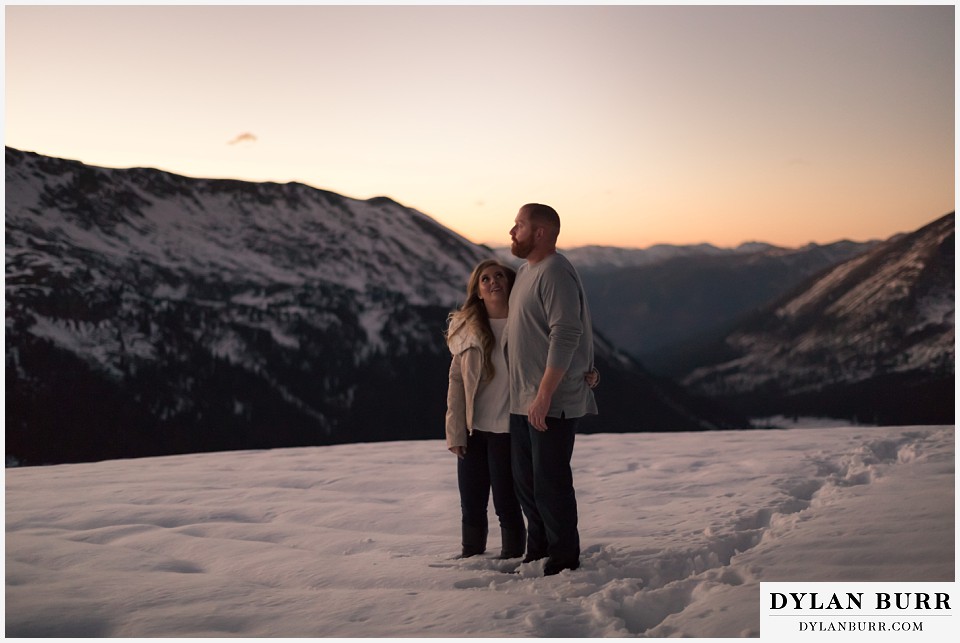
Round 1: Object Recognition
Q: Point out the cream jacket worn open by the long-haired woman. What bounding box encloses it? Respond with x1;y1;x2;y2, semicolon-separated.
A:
446;321;483;448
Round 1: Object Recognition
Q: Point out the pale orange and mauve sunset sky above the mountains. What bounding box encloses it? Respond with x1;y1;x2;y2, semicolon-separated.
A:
5;4;955;247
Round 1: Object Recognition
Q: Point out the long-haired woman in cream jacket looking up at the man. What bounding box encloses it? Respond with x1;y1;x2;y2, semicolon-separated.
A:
446;259;527;558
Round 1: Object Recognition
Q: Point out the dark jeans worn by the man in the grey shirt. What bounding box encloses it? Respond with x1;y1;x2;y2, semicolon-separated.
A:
510;414;580;564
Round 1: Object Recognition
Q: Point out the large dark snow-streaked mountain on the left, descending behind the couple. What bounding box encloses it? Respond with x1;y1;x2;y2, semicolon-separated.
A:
5;148;743;464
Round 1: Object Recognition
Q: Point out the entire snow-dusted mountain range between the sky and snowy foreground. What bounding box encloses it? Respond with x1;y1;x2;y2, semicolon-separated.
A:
5;148;954;464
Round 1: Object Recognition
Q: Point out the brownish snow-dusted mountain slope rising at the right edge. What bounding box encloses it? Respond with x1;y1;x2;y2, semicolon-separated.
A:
683;213;955;423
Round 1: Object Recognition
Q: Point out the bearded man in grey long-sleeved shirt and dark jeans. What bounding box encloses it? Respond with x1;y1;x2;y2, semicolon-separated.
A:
505;203;597;576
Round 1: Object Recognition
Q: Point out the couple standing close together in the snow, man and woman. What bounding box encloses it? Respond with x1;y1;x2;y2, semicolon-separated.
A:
446;203;599;576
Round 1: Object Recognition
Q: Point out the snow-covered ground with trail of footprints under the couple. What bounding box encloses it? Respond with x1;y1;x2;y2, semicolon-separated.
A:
6;427;955;637
